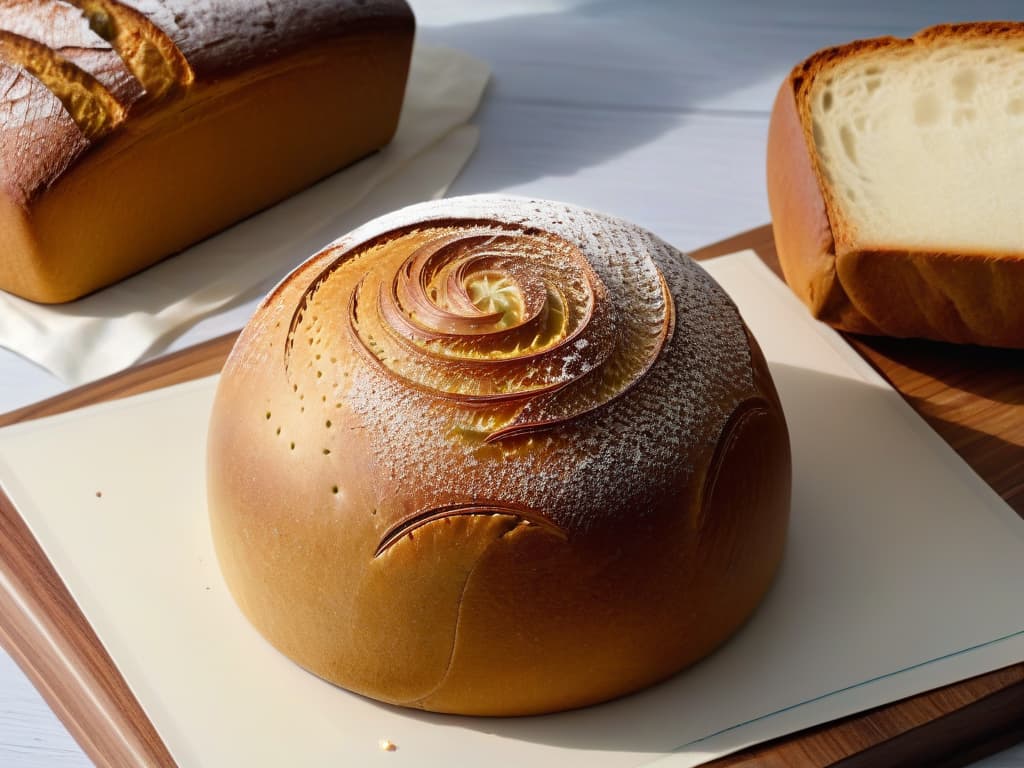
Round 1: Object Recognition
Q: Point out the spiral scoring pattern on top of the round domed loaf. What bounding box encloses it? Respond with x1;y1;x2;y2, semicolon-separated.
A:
287;221;675;441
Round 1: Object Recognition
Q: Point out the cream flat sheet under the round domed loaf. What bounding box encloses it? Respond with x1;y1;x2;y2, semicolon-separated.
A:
0;252;1024;768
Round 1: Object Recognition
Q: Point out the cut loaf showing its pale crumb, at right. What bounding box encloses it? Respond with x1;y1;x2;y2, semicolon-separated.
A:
768;23;1024;347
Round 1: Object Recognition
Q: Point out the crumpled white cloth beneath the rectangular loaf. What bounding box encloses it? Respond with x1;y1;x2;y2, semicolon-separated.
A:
0;46;489;385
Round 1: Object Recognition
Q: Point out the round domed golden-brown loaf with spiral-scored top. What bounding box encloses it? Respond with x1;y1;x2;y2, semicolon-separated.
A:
208;197;791;715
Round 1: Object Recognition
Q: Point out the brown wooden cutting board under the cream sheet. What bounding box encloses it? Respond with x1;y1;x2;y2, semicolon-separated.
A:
0;226;1024;768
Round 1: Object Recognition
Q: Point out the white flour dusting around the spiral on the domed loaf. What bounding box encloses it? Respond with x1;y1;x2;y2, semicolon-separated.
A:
268;197;755;536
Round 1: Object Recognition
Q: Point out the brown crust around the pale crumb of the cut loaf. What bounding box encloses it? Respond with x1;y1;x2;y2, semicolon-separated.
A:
767;22;1024;347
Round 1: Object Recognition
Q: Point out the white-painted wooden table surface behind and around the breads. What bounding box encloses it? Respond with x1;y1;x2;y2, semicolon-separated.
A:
0;0;1024;768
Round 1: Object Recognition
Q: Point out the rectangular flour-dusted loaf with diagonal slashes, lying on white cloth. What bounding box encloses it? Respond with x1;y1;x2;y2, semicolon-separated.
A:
0;0;414;302
